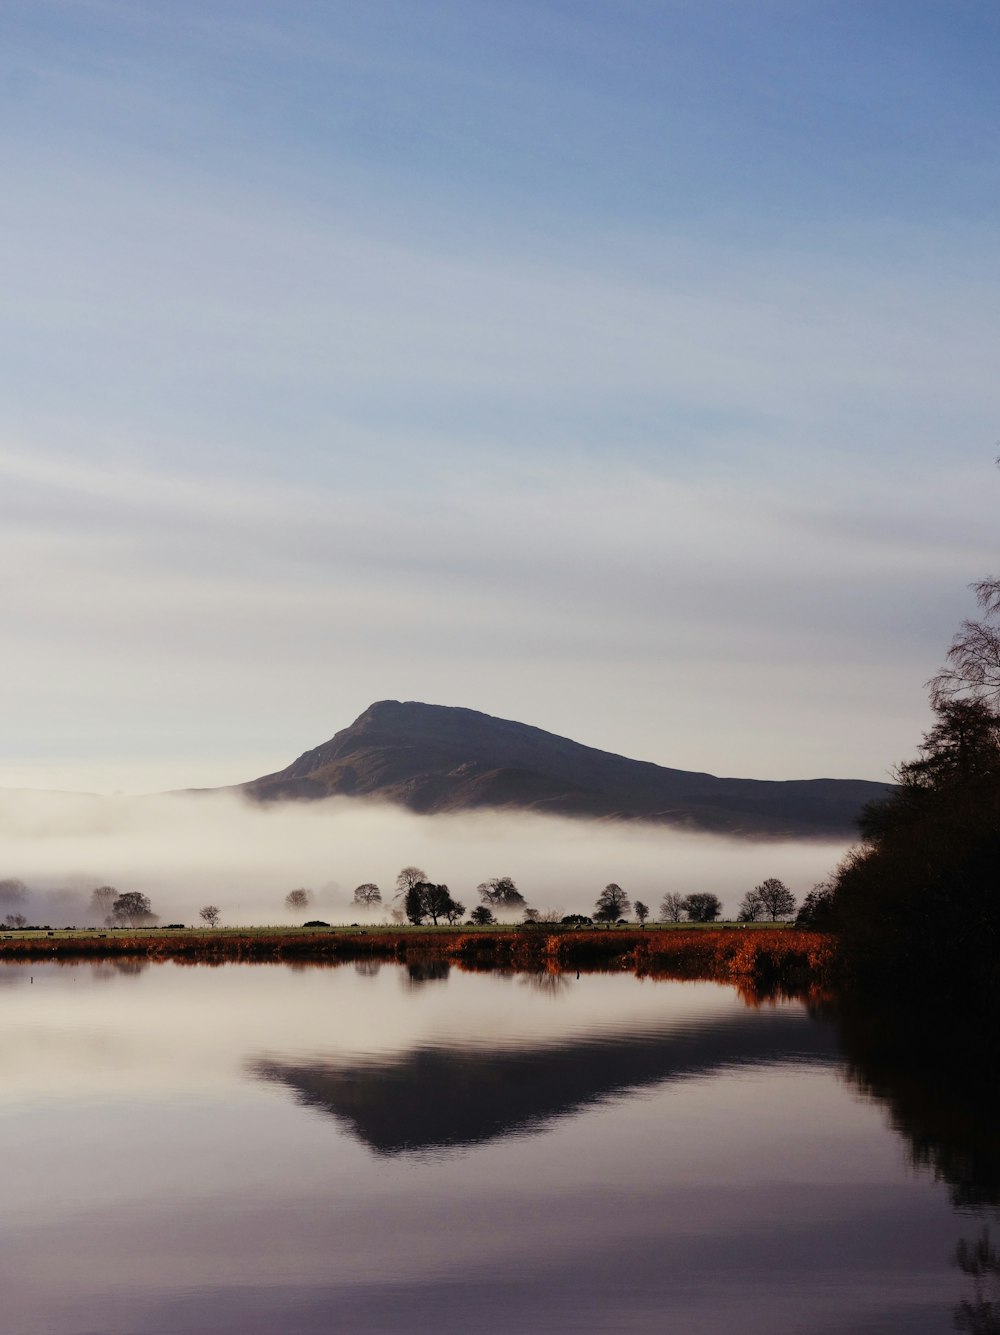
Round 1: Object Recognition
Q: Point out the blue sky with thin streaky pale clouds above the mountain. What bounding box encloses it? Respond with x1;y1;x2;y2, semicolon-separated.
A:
0;0;1000;793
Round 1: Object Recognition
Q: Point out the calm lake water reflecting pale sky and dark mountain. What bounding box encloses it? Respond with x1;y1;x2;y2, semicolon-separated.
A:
0;964;1000;1335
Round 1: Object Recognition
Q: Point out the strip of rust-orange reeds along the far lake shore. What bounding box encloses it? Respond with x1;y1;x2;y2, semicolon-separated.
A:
0;928;834;985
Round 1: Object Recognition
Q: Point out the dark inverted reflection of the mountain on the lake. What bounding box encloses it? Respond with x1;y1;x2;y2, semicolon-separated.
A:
248;1009;837;1155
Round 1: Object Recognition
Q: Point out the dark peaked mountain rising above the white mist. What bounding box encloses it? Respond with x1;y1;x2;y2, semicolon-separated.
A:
239;700;889;838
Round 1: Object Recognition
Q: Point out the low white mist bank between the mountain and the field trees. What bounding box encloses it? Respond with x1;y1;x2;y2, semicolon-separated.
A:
0;792;844;926
